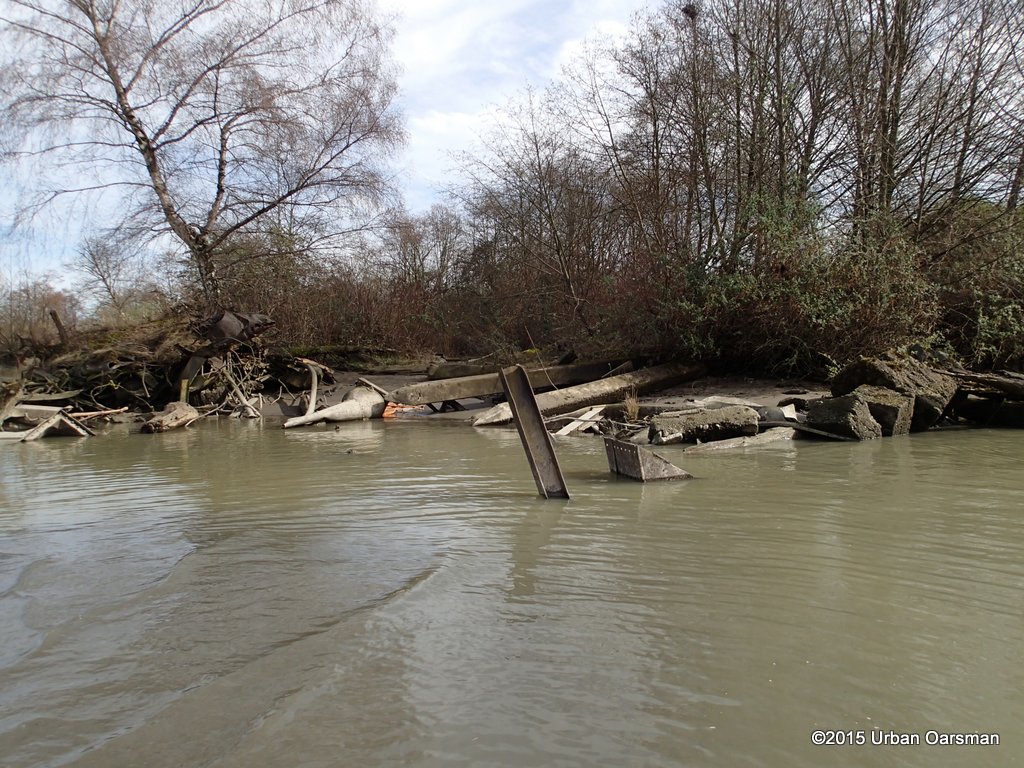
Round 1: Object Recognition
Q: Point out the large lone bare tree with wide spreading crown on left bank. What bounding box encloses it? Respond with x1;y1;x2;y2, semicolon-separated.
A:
0;0;401;303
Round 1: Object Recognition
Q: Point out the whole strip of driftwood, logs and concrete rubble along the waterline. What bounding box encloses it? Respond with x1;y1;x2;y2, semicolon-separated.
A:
0;311;1024;450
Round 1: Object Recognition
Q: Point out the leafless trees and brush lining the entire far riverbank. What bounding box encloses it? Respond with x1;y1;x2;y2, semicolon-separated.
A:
0;0;1024;428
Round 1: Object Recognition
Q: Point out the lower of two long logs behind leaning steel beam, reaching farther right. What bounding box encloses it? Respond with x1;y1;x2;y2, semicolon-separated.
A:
473;362;706;427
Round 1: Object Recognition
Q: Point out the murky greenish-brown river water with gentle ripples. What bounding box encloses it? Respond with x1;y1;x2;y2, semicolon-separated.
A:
0;421;1024;768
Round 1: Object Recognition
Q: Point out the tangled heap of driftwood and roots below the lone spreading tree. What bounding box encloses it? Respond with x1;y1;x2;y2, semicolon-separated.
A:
0;310;334;432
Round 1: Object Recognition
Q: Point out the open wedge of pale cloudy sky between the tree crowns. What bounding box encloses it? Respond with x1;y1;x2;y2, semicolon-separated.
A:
378;0;656;212
